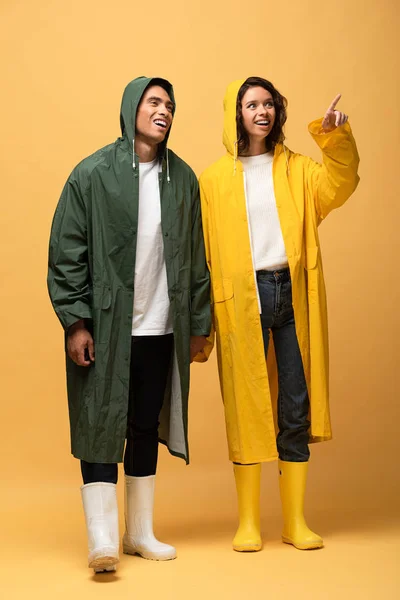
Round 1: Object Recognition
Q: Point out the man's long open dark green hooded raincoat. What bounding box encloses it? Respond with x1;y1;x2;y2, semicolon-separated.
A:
48;77;211;463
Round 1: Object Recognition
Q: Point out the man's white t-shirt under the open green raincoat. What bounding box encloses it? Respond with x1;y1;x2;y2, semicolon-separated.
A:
132;159;173;336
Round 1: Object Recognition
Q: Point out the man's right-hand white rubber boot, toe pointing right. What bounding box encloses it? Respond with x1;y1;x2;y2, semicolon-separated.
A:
122;475;176;560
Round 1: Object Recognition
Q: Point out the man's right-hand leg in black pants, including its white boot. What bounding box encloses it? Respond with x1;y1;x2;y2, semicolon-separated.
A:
123;334;176;560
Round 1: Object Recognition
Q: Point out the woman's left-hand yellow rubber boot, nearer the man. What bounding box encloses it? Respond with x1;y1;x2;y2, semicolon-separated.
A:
233;464;262;552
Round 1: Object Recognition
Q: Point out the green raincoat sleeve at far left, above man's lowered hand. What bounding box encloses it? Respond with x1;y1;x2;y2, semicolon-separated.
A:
47;173;92;330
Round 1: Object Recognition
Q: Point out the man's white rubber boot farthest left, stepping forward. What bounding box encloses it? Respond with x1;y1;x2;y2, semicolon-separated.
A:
81;482;119;573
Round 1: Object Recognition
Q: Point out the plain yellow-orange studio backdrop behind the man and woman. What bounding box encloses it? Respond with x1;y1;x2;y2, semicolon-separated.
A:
0;0;400;599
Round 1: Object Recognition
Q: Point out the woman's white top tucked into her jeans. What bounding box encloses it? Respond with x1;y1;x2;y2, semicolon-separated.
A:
240;152;288;271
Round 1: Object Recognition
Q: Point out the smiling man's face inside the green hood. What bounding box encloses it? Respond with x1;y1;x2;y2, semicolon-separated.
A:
136;85;174;144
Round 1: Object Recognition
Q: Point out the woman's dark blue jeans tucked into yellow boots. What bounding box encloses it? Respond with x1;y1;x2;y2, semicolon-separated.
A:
257;269;310;462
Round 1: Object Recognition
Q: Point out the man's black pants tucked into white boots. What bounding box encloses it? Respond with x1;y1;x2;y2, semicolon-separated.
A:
81;333;174;483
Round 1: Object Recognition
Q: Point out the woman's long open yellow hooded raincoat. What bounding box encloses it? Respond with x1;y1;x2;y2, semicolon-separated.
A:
200;81;359;464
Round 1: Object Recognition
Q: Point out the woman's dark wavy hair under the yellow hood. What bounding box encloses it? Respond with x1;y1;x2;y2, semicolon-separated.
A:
236;77;287;154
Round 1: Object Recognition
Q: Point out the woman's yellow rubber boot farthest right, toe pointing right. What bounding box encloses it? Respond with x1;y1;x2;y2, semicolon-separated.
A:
278;460;324;550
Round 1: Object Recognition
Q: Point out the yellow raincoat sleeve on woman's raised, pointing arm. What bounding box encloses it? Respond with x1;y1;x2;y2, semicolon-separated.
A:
307;119;360;220
